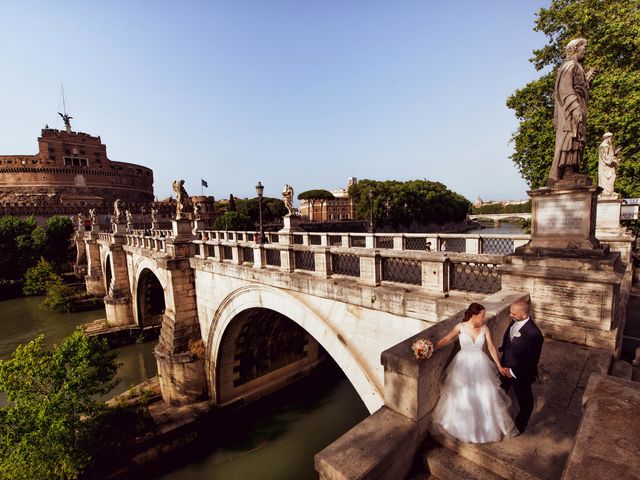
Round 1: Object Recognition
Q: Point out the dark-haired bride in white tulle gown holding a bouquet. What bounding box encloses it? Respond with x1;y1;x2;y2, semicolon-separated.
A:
433;303;518;443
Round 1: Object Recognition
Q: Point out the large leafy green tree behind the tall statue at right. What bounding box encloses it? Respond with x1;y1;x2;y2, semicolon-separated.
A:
507;0;640;197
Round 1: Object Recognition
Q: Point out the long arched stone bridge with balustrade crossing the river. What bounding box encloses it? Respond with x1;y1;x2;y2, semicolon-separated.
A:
84;222;528;412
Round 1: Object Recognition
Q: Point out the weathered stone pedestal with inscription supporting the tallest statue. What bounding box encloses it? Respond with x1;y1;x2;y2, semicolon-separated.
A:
499;182;624;351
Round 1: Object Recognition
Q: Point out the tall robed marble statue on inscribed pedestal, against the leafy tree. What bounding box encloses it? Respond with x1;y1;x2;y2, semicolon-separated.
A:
548;38;596;186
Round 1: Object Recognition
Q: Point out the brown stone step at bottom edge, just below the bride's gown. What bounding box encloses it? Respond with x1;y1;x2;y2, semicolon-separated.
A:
424;447;504;480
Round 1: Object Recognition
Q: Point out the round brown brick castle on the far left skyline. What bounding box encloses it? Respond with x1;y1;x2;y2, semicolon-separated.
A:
0;121;154;222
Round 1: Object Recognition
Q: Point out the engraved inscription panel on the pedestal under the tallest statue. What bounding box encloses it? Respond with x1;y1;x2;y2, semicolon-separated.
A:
535;198;584;236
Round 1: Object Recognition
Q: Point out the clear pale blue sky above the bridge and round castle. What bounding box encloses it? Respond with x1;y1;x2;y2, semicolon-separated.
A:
0;0;549;201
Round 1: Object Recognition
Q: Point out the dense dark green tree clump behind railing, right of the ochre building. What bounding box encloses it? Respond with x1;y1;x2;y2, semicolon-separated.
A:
349;179;471;230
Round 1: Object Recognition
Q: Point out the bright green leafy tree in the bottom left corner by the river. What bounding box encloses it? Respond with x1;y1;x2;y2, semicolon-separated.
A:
0;329;118;480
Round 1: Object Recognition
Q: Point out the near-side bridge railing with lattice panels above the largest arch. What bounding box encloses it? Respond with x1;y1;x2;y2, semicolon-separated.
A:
191;230;526;294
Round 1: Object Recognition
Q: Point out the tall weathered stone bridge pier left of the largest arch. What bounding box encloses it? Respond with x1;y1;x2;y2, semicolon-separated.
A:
154;258;207;405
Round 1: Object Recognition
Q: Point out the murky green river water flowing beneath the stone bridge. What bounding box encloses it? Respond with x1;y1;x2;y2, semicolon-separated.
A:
0;297;368;480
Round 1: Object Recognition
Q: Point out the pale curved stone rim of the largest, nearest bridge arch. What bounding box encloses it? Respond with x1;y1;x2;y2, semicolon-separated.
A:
205;284;384;412
